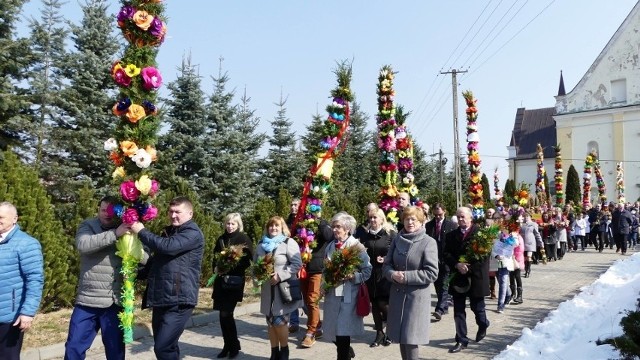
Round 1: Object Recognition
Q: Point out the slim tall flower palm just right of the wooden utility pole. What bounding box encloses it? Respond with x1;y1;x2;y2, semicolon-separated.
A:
462;90;482;221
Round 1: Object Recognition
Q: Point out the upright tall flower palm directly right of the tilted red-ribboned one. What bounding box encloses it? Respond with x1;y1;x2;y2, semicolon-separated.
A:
376;65;399;224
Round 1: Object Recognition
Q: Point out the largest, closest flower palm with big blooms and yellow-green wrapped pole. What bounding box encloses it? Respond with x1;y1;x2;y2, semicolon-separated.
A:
104;0;167;343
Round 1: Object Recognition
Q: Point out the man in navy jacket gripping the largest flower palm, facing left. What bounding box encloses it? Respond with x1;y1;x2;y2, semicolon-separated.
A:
131;197;204;360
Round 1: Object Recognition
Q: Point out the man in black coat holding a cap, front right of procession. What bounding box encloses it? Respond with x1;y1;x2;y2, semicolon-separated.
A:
444;207;489;353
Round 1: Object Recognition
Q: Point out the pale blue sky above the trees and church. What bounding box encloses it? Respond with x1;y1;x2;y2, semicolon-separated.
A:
21;0;636;186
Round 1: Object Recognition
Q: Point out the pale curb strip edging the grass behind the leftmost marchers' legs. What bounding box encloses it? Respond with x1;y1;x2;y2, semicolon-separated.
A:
20;301;260;360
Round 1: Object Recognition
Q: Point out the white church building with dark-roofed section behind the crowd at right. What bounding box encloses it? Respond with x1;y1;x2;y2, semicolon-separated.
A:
508;3;640;203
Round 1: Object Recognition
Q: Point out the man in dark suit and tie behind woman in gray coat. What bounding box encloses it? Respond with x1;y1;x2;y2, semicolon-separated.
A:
425;203;457;321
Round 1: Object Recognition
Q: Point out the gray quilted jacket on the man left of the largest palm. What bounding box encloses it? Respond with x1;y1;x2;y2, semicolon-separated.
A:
76;218;122;308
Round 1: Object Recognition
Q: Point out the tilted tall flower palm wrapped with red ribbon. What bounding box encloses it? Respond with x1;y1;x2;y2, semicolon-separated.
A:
292;61;353;277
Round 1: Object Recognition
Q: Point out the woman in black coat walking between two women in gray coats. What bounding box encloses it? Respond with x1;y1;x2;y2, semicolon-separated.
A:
359;209;396;347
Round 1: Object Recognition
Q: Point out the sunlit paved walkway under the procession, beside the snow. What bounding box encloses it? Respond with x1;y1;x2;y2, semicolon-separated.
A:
32;248;626;360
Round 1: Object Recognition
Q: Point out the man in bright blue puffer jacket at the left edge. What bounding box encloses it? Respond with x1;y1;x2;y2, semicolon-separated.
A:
0;202;44;360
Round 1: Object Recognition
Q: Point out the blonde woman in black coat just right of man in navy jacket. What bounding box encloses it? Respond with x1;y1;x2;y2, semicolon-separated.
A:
211;213;253;359
